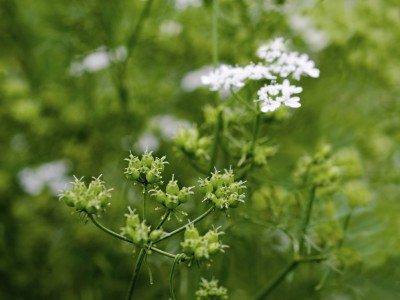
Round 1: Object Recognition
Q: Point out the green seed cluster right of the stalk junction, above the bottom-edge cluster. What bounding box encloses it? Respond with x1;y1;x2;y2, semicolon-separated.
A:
181;225;227;261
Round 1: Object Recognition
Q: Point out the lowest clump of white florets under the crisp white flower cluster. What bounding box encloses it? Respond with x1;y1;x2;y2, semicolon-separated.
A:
257;79;303;112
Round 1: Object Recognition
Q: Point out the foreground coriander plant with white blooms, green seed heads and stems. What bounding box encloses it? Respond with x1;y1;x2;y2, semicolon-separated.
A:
56;1;370;299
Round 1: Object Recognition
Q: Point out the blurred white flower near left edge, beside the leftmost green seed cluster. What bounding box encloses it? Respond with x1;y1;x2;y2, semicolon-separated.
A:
18;160;71;195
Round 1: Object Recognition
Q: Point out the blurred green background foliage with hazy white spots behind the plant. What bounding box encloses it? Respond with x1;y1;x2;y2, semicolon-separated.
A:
0;0;400;299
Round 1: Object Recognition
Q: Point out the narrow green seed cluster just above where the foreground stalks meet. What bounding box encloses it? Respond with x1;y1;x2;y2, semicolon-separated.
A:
121;208;155;247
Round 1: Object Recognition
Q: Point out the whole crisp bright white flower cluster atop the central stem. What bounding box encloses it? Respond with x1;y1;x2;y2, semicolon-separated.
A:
201;38;319;112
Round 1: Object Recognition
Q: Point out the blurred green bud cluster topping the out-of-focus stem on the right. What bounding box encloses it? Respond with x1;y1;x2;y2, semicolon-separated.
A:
294;144;342;188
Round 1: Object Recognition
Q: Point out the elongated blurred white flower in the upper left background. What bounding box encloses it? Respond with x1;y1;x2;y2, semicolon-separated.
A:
69;46;128;76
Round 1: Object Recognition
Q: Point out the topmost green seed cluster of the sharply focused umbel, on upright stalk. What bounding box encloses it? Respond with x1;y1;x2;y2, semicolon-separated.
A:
125;152;167;184
